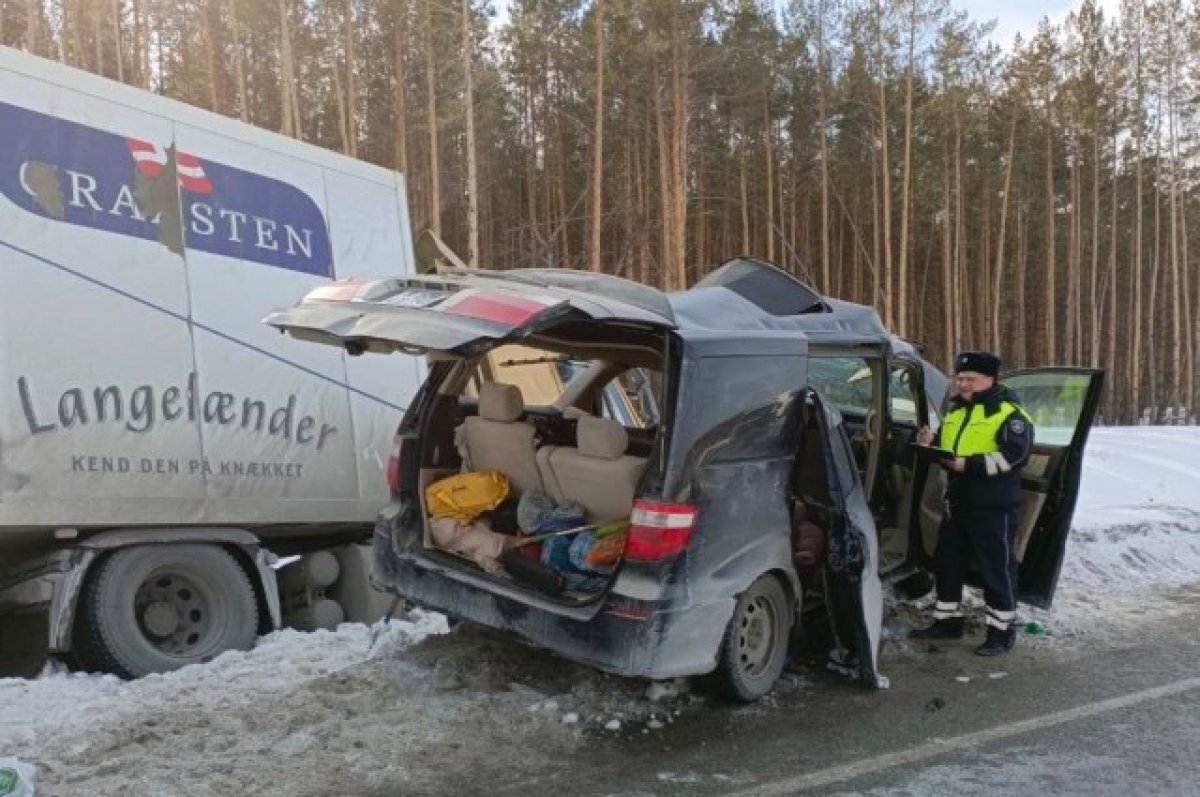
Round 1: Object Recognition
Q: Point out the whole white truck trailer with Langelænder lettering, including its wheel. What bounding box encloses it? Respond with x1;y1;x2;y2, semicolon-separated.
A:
0;47;424;677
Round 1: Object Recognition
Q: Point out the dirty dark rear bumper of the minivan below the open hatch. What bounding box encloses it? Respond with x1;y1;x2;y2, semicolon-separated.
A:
372;525;734;679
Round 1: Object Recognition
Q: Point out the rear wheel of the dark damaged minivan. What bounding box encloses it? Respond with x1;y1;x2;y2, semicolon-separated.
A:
718;575;792;702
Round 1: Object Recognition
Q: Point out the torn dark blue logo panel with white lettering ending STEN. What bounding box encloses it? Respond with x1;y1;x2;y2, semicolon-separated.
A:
0;102;332;277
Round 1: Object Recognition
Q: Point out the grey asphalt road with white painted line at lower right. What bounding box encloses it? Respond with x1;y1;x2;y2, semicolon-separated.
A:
490;593;1200;797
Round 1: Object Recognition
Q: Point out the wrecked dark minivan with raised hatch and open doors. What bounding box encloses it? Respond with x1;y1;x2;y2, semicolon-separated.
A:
266;258;1100;701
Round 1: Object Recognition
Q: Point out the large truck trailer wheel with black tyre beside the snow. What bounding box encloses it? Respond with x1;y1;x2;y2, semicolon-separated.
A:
76;545;258;678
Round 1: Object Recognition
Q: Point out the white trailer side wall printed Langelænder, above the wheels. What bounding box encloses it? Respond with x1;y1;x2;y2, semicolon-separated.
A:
0;48;421;535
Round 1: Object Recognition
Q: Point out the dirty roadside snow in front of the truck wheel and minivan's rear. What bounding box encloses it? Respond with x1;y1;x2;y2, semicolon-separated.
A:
0;612;690;797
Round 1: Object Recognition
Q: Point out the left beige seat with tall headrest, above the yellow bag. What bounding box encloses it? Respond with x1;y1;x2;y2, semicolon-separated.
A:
458;382;544;496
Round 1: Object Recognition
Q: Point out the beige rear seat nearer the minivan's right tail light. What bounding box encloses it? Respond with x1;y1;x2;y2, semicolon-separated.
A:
538;415;646;522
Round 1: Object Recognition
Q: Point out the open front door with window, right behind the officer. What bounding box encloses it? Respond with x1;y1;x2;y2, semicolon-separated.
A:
1001;367;1104;607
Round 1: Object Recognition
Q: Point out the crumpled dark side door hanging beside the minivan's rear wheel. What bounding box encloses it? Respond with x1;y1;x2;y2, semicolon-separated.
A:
808;390;883;685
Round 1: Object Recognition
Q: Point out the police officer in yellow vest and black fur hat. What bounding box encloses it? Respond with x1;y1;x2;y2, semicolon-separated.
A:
912;352;1033;655
